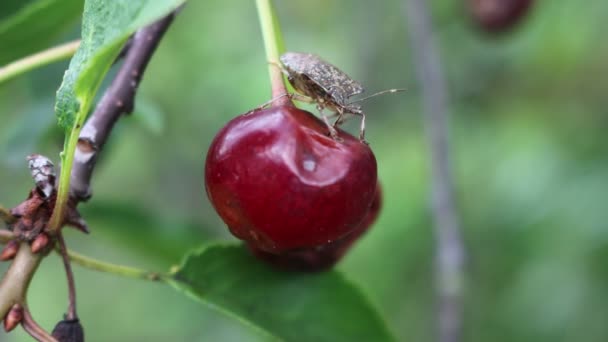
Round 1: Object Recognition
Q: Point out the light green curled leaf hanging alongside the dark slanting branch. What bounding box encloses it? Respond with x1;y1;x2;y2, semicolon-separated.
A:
55;0;185;131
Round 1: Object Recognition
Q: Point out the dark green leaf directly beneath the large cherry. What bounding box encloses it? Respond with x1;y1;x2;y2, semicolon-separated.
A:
171;245;394;342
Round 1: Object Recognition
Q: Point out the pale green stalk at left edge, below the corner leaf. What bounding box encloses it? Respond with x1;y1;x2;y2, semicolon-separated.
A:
0;40;80;84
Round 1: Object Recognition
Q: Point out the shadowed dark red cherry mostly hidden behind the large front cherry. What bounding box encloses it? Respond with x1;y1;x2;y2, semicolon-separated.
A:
249;183;382;272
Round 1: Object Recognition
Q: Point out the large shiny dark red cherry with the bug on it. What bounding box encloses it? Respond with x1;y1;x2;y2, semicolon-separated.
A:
205;106;377;253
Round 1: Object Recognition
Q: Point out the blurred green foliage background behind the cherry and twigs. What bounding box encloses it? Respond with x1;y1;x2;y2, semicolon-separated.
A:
0;0;608;342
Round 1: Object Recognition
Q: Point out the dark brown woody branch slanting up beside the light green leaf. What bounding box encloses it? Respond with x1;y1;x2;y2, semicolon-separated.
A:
70;12;175;201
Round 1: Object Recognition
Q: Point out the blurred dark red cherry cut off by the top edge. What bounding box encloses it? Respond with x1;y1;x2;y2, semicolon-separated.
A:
468;0;533;33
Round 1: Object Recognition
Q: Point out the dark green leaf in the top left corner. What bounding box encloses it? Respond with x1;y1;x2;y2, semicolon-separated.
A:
0;0;83;65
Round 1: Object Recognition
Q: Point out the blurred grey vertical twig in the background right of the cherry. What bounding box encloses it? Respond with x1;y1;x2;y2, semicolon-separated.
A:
407;0;465;342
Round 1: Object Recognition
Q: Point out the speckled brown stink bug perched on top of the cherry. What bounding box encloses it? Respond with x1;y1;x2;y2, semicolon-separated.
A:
279;52;404;141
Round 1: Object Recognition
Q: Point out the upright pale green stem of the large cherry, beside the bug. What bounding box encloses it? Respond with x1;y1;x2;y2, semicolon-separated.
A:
256;0;293;106
